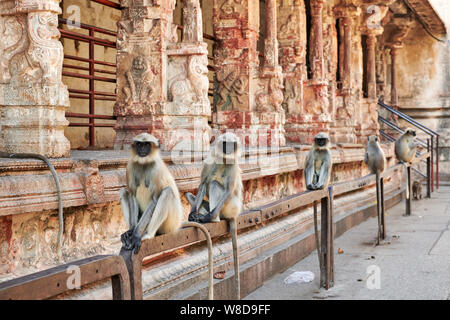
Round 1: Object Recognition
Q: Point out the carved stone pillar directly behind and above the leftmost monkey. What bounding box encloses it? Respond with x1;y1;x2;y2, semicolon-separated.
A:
114;0;211;152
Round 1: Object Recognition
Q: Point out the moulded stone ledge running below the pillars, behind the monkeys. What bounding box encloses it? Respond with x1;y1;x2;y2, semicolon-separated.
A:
0;146;392;216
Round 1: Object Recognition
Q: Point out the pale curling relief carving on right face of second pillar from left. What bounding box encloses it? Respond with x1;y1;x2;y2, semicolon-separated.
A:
187;55;209;101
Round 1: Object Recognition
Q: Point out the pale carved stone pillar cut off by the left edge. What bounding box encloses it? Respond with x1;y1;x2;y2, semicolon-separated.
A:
0;0;70;158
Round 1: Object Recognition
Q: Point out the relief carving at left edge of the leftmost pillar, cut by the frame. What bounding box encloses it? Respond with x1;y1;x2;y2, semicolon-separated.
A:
0;16;28;83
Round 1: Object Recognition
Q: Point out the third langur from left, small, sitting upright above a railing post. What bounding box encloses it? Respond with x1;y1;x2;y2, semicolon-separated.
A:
305;132;333;190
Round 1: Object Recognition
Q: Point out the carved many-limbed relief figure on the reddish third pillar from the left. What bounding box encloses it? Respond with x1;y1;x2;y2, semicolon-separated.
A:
216;69;247;110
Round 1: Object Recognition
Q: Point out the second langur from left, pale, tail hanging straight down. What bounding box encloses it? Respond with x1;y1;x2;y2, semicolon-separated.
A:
186;132;243;300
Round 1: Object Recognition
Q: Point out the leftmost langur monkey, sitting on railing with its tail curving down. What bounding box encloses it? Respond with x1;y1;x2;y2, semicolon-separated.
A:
120;133;214;300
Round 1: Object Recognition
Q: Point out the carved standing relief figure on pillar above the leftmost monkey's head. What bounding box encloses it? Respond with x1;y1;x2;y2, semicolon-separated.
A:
123;56;154;104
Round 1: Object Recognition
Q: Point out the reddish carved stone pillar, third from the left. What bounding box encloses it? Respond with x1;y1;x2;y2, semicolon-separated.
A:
213;0;285;146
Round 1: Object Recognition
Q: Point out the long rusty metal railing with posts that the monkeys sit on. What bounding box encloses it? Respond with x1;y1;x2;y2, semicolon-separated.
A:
0;152;432;300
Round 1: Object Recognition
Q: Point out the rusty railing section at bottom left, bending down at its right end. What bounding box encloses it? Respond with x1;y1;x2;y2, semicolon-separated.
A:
0;255;130;300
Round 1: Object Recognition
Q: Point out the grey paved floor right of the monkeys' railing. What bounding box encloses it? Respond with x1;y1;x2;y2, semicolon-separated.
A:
246;186;450;300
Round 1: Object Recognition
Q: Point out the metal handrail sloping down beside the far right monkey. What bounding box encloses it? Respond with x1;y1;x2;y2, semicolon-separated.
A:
378;101;440;192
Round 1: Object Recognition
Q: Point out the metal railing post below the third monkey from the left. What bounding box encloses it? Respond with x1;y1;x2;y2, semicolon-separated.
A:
320;187;334;290
